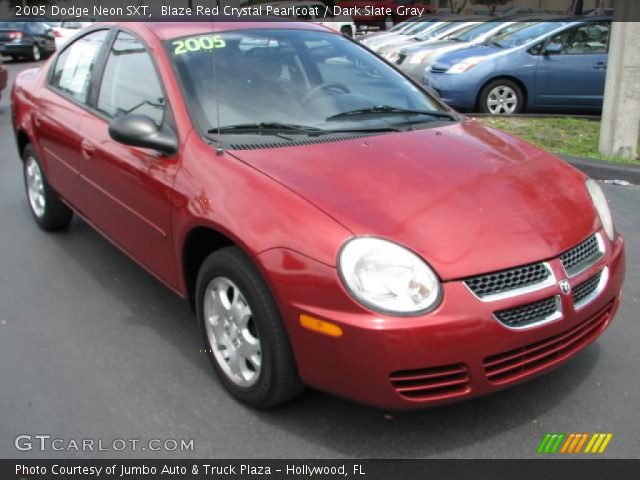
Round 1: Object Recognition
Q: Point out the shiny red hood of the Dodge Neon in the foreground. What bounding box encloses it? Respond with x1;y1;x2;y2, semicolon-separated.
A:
229;120;598;280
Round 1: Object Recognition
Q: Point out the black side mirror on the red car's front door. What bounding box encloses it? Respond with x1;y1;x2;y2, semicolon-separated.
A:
109;113;178;155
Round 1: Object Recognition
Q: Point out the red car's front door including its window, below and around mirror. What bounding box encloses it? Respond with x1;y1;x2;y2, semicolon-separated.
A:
80;31;178;286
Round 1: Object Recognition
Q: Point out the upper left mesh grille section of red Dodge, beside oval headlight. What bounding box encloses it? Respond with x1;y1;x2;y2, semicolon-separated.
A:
464;263;551;299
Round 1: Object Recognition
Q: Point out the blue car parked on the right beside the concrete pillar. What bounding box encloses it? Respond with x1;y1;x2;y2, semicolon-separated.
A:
423;18;611;115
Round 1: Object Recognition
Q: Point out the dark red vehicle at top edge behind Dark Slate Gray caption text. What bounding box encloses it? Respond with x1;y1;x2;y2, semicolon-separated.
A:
336;0;436;30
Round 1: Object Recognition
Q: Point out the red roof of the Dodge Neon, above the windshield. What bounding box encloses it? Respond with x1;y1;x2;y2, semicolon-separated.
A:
107;17;328;40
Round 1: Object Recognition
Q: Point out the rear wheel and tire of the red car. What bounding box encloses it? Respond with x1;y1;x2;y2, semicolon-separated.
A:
22;145;73;231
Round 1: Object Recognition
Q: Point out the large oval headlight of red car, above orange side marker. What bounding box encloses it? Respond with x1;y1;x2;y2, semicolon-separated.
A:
338;237;440;315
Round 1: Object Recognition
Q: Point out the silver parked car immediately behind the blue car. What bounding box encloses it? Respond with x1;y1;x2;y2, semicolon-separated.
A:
395;21;527;82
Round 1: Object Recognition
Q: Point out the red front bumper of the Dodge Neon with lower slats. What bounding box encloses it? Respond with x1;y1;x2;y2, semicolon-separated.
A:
259;232;625;409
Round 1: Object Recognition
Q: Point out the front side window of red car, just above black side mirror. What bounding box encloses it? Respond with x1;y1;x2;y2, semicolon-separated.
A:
96;32;166;126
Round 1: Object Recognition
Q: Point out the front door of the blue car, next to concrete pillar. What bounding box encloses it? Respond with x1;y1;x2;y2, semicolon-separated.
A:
535;22;611;108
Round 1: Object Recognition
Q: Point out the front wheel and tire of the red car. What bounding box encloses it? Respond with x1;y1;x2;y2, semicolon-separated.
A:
196;247;304;409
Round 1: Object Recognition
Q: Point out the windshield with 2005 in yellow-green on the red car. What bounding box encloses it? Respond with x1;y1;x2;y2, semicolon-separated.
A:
167;29;450;133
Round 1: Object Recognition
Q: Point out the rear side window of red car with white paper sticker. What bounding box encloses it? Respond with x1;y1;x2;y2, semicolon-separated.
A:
50;30;109;103
